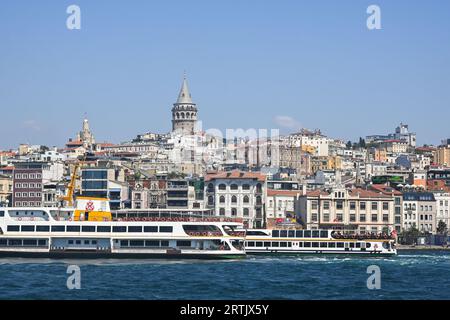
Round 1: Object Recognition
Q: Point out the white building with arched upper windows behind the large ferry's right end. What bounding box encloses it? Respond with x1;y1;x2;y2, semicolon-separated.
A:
205;170;267;228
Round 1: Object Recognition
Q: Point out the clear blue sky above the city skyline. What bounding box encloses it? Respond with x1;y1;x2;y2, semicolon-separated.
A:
0;0;450;149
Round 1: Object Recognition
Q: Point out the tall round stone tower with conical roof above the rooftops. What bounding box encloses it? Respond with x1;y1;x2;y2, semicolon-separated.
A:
172;75;197;135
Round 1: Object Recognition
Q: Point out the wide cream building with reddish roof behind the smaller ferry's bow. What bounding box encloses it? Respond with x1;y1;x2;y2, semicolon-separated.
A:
299;187;395;233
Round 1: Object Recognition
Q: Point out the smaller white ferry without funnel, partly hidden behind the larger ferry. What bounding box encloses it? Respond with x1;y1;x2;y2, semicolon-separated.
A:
245;229;397;255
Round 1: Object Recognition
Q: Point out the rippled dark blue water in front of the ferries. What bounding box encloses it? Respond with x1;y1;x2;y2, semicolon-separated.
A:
0;251;450;300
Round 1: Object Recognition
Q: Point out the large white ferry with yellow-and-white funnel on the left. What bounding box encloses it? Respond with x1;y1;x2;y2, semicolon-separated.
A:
0;197;245;259
